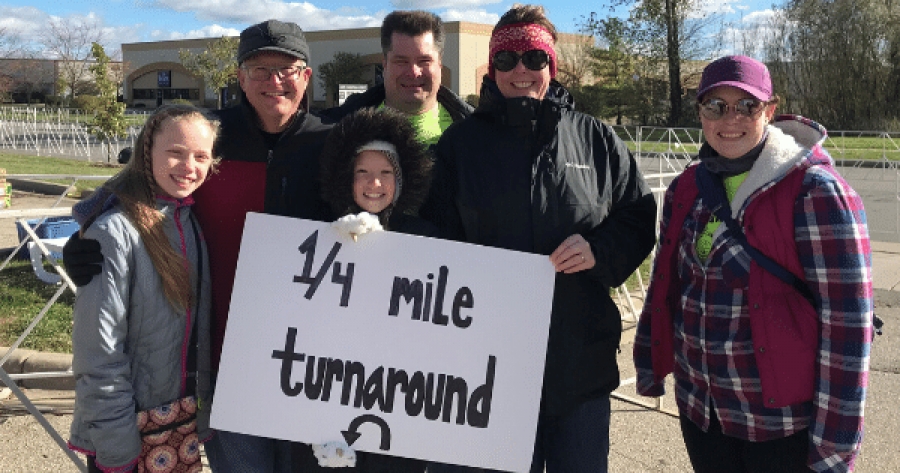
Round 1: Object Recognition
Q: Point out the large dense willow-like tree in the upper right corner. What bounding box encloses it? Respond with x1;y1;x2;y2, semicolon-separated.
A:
764;0;900;130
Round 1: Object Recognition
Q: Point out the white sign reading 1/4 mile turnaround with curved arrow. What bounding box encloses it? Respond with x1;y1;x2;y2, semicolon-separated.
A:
212;213;554;471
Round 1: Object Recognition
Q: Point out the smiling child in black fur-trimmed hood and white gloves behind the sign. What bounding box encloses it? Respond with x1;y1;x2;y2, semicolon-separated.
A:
293;108;438;473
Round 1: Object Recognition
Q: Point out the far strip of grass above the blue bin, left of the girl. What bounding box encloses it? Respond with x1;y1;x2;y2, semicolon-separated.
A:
0;152;122;197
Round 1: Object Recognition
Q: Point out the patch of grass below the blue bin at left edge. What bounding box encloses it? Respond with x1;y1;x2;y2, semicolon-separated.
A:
0;260;75;353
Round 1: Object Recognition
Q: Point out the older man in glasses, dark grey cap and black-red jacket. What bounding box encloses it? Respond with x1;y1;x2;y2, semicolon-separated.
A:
194;20;330;473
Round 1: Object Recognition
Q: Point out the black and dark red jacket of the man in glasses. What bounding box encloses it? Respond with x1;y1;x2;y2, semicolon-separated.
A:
193;100;331;370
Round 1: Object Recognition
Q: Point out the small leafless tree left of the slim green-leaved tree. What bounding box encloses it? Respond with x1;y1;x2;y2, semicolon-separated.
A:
41;18;104;100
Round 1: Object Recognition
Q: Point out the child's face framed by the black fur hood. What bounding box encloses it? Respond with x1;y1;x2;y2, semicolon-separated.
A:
353;150;396;214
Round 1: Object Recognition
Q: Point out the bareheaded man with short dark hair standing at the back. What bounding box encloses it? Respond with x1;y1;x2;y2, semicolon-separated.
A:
320;10;472;146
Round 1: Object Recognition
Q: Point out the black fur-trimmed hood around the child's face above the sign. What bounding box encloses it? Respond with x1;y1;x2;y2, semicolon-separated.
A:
319;108;433;229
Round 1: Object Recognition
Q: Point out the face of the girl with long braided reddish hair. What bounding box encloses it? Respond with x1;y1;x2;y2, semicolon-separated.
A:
151;118;215;199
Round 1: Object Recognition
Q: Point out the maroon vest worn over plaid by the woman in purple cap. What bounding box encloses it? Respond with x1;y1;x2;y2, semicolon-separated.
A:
648;166;820;408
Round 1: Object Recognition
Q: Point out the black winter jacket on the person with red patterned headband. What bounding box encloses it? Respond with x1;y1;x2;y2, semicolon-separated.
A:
423;78;656;417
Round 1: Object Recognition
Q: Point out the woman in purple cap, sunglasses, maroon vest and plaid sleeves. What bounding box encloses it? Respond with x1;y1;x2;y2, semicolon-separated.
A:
634;56;873;473
